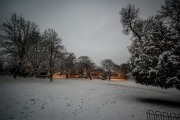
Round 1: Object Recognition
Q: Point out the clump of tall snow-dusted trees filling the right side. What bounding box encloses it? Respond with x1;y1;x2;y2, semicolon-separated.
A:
120;0;180;90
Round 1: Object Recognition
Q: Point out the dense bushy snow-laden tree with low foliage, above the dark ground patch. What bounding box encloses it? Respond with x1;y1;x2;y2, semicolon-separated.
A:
129;21;178;88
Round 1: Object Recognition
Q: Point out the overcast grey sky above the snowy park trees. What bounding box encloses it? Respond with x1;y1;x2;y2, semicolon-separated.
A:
0;0;164;65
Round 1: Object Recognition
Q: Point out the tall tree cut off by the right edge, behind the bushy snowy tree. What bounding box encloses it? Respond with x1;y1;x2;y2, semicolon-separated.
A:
158;0;180;90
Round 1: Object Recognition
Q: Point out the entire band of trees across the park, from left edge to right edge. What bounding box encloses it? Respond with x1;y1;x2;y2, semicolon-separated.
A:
0;0;180;90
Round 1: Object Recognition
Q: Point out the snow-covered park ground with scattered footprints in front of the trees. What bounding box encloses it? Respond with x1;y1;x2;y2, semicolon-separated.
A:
0;76;180;120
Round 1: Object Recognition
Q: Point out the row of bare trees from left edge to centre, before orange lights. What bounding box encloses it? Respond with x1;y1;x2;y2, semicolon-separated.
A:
0;13;127;82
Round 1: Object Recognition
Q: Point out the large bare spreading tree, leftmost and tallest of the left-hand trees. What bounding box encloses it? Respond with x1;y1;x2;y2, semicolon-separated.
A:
0;14;38;78
